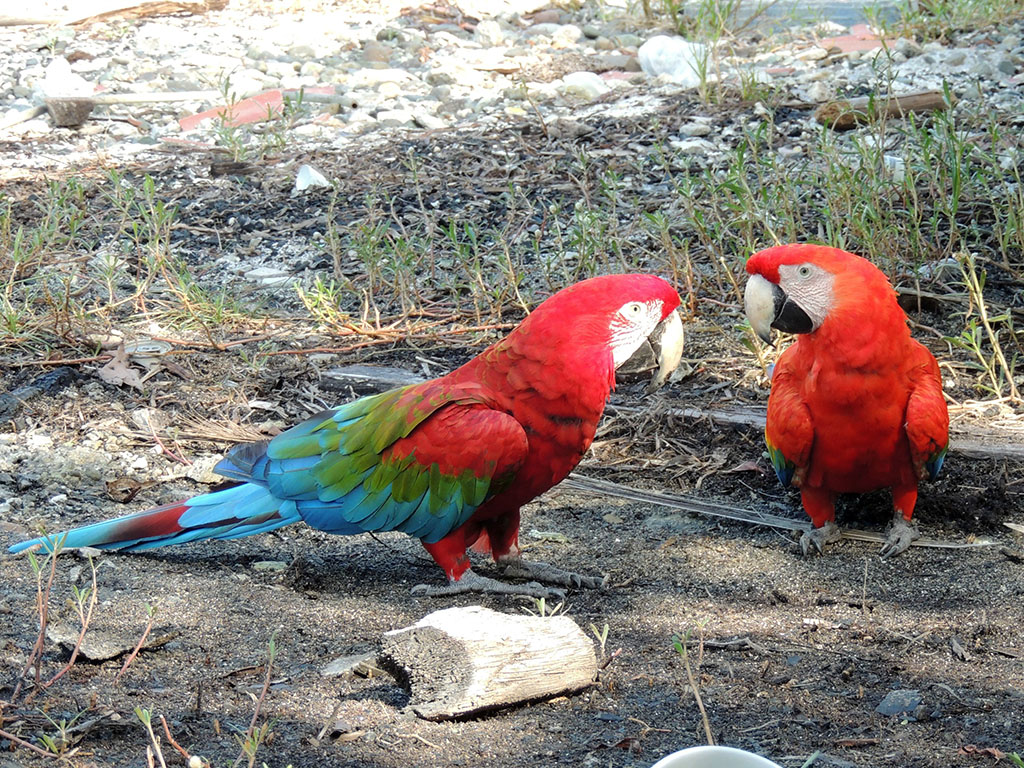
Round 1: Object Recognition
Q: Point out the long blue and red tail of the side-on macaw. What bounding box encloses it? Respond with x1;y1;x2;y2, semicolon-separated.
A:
9;482;302;552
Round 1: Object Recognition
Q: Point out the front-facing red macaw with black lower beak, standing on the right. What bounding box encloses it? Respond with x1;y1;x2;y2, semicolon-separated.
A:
744;245;949;557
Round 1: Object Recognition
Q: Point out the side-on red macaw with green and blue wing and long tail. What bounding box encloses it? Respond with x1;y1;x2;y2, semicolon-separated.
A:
10;274;682;594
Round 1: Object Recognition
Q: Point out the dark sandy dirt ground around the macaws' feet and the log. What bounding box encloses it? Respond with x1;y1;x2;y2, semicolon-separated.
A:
0;325;1024;766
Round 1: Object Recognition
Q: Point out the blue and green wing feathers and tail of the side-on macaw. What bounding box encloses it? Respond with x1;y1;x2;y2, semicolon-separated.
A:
11;388;503;552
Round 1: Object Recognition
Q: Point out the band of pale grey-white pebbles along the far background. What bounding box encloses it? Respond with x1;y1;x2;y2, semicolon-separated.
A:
0;0;1024;198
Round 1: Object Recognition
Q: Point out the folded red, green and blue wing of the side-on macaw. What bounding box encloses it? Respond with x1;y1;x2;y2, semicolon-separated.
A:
241;381;528;542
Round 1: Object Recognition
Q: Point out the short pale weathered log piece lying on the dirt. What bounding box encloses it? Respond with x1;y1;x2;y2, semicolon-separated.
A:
377;605;597;720
